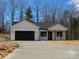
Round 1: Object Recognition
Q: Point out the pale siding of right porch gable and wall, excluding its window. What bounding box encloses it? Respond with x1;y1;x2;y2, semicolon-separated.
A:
48;24;68;40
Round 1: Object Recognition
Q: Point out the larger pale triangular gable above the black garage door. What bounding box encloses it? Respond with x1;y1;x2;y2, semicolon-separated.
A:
12;20;39;28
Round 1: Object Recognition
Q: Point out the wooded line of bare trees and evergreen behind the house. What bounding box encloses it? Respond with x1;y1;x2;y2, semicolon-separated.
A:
0;0;79;39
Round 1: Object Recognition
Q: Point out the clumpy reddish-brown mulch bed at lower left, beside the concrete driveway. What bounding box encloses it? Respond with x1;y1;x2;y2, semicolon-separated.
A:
0;42;19;59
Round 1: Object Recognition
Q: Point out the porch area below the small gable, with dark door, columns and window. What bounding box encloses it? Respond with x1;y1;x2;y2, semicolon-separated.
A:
48;31;66;40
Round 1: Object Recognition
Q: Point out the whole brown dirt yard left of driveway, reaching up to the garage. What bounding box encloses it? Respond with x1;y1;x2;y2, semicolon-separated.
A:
0;34;19;59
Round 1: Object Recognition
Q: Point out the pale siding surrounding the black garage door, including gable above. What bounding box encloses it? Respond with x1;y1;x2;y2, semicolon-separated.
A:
11;20;39;40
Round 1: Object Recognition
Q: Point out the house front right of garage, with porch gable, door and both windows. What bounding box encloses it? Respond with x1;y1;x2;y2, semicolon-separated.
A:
39;24;68;40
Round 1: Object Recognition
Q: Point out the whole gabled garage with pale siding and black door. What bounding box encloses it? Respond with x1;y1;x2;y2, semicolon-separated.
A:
11;20;40;41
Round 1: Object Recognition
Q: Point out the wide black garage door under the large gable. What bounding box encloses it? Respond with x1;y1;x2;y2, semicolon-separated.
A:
15;31;34;41
